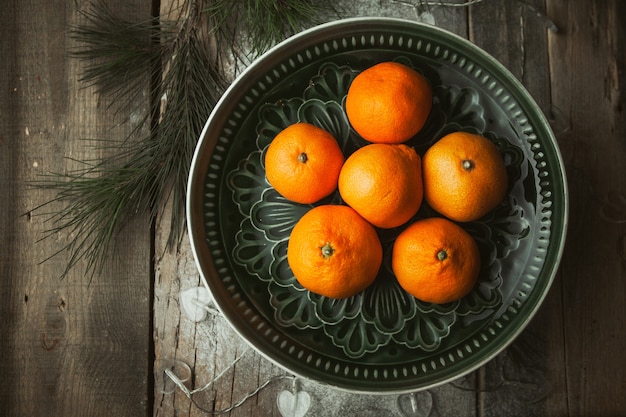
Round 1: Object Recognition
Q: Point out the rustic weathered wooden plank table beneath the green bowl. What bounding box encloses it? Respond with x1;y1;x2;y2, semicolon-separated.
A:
0;0;626;417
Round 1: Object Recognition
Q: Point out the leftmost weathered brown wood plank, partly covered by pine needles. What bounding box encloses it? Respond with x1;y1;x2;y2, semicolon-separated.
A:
0;0;151;417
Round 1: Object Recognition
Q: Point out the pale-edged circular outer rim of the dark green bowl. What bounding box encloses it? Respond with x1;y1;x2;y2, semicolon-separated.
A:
186;17;569;395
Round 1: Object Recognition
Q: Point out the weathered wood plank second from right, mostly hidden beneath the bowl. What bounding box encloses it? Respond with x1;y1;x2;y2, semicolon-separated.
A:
469;0;564;416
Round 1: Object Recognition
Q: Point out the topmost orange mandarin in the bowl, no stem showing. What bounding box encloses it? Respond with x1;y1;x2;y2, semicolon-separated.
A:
346;62;433;143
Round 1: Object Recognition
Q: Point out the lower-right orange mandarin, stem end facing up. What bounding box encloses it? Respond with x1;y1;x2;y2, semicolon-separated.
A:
391;217;480;304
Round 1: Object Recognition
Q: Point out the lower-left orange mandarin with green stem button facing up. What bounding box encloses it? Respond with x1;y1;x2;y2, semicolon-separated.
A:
287;205;383;298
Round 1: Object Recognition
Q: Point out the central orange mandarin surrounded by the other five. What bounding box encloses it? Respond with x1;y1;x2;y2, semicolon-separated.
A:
339;143;422;229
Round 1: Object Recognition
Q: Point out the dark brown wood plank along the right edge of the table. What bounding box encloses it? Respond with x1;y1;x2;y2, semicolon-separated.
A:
546;1;626;416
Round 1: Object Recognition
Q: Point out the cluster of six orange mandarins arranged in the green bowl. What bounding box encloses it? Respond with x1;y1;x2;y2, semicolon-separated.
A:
265;62;507;303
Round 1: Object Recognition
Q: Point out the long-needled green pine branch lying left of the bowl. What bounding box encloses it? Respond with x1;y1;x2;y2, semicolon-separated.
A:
33;0;334;279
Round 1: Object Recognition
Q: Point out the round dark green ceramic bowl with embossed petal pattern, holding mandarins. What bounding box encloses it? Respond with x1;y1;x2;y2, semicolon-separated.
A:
187;18;568;393
